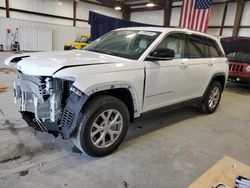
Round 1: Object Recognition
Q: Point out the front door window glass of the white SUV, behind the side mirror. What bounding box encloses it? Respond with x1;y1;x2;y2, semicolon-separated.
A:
156;33;186;59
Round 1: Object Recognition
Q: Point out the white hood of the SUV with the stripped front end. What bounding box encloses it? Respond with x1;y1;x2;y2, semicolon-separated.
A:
5;50;128;76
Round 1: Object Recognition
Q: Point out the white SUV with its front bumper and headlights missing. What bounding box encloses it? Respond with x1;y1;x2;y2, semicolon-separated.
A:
5;27;228;156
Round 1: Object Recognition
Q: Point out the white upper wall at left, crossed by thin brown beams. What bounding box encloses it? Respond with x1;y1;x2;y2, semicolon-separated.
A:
3;0;122;28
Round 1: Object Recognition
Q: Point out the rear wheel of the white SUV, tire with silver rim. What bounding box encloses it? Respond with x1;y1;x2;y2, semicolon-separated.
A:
200;81;222;114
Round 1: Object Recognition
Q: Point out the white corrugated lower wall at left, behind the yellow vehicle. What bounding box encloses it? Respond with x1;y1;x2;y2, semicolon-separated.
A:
0;18;90;51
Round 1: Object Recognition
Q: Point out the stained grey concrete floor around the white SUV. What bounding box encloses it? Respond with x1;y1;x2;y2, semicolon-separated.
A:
0;53;250;188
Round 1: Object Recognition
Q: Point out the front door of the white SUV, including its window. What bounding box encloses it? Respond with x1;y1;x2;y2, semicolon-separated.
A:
143;33;188;112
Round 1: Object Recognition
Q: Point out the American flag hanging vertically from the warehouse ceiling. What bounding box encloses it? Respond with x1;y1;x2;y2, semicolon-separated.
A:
179;0;213;32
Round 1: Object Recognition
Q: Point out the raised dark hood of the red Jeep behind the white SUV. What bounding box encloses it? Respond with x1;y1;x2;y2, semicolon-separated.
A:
221;37;250;55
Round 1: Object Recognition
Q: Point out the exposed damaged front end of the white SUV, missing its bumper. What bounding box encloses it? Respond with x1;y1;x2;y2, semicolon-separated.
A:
14;72;87;138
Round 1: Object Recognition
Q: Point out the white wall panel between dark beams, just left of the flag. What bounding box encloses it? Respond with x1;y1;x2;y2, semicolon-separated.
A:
131;10;164;26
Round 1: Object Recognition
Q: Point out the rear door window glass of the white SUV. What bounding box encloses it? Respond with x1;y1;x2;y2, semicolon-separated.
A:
188;35;208;58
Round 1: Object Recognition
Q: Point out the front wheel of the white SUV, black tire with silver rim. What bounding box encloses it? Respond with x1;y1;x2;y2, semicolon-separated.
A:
73;95;129;157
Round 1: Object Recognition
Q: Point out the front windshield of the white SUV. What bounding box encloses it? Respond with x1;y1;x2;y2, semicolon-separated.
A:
84;30;160;59
